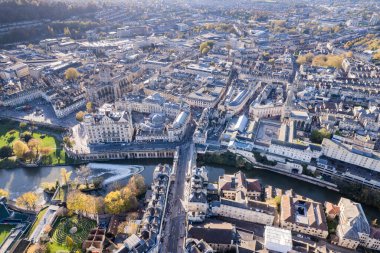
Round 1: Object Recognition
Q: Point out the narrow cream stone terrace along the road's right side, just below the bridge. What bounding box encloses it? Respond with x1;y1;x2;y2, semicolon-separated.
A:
185;167;209;222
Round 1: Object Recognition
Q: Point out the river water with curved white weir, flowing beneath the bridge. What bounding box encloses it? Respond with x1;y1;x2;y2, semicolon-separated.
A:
0;159;380;220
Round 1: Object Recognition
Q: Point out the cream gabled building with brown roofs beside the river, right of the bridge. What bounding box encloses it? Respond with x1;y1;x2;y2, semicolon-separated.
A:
218;171;262;202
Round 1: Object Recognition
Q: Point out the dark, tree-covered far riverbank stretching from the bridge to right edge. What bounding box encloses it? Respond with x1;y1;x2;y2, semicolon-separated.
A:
197;151;380;215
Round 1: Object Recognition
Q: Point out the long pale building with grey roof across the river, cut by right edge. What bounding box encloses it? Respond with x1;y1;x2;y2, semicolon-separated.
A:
322;139;380;172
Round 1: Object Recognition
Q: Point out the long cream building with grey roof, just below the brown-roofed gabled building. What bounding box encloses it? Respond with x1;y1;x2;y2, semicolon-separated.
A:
211;198;276;225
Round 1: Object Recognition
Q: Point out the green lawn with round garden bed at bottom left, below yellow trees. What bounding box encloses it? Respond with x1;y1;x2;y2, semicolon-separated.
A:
49;215;96;252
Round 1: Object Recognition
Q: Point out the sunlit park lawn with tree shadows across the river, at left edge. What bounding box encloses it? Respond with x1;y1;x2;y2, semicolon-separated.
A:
0;120;67;167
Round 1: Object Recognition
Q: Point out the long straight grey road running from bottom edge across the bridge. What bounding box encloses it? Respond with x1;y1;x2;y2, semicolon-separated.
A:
161;142;193;253
